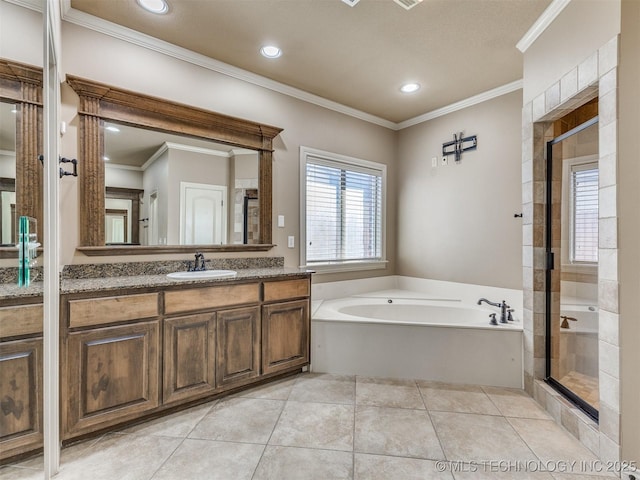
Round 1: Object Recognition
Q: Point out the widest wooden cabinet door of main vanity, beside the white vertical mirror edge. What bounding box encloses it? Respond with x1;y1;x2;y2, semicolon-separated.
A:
62;321;160;437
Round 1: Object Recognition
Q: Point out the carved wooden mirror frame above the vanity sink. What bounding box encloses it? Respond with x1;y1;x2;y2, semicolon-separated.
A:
66;75;282;255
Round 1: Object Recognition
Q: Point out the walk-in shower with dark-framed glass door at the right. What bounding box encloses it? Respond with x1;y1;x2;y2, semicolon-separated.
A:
546;101;599;419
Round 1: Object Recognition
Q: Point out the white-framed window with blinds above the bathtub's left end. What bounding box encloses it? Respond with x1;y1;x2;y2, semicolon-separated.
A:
300;147;386;271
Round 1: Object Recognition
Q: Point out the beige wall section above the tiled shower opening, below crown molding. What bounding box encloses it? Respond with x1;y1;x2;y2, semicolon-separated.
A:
523;0;620;104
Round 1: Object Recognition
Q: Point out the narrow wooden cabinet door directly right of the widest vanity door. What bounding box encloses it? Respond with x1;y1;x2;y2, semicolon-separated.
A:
162;313;216;403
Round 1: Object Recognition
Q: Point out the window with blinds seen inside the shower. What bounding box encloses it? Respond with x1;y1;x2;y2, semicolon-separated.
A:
571;163;598;263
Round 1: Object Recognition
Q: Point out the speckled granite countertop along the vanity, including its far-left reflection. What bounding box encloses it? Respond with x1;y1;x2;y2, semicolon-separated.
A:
0;267;311;299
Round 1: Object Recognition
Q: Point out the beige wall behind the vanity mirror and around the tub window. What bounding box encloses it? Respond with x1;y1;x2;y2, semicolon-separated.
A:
55;23;397;281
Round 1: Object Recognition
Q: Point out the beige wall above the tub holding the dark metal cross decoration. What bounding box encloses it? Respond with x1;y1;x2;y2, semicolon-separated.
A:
397;91;522;289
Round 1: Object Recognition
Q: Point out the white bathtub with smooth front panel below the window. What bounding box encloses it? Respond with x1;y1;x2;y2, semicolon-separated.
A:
311;277;523;388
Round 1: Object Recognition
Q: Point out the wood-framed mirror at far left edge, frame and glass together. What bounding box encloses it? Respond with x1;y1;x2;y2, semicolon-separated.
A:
0;59;43;257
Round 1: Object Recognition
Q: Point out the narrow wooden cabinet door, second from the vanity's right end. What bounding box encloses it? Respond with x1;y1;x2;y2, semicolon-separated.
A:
216;306;260;387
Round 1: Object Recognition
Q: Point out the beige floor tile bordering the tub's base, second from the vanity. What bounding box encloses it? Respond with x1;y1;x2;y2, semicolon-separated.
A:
356;377;425;410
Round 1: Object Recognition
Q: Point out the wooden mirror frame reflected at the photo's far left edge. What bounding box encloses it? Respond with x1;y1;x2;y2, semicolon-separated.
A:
0;59;44;258
